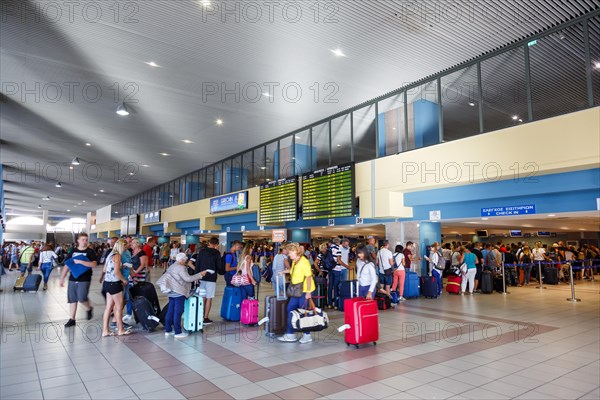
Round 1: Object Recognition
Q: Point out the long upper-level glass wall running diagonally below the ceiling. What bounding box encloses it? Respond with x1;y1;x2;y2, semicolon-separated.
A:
112;10;600;217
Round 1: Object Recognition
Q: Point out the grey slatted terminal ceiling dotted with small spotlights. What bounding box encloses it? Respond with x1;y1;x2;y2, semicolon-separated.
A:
0;0;598;216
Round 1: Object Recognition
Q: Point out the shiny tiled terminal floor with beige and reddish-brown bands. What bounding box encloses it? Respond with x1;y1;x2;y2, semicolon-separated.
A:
0;271;600;400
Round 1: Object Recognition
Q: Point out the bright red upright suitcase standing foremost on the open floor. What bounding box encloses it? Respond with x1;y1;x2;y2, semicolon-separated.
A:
344;298;379;349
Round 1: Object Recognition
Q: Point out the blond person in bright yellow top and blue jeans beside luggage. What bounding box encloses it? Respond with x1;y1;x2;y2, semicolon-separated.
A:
278;239;314;343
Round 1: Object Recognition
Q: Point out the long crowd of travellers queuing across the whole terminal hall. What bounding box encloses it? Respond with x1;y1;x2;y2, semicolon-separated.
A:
1;233;600;343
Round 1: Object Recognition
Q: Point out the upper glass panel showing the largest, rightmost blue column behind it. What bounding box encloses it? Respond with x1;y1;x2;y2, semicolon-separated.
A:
407;81;440;149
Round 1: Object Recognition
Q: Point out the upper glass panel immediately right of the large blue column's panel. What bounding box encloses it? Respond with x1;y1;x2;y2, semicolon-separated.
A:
441;65;479;142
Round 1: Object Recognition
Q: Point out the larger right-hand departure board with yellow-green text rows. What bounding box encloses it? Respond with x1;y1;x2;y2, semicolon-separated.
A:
302;163;356;220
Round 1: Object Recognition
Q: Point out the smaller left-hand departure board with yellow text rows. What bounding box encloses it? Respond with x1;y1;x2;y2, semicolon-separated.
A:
259;176;298;225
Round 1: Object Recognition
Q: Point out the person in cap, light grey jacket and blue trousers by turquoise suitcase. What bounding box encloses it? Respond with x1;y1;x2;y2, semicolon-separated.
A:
161;253;207;339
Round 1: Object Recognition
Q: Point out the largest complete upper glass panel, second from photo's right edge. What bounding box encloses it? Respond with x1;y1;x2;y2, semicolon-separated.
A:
529;24;588;120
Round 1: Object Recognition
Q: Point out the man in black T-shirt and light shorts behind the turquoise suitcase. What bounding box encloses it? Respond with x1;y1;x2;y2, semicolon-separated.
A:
196;237;221;325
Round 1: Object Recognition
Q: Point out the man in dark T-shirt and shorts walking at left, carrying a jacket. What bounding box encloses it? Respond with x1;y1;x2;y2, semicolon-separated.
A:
60;233;97;328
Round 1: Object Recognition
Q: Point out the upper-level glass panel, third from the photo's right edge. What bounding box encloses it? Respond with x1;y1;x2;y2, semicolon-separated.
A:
481;47;527;132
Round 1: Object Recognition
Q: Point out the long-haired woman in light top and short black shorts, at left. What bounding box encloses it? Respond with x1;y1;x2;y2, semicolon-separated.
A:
102;239;131;337
